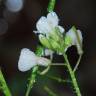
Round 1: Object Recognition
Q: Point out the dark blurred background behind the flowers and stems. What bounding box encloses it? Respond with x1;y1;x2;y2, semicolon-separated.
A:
0;0;96;96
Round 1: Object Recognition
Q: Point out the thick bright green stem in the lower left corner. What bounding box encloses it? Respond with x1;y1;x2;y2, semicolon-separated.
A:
0;69;12;96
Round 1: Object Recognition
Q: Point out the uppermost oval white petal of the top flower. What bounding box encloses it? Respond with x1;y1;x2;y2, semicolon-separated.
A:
47;12;59;28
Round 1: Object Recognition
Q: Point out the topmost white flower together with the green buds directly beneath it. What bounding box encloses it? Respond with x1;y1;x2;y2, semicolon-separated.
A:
34;12;64;53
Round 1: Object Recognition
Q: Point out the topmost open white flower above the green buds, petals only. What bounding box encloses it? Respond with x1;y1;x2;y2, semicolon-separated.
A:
34;12;64;35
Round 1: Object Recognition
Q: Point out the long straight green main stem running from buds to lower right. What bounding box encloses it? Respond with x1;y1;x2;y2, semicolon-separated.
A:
63;53;81;96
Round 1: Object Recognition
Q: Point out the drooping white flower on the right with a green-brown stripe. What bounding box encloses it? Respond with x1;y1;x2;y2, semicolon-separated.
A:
66;28;83;54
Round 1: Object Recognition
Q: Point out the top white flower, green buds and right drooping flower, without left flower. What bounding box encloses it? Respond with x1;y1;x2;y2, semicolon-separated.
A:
34;12;83;54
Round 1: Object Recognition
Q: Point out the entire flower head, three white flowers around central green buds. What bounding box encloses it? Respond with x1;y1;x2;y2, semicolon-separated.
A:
18;12;83;71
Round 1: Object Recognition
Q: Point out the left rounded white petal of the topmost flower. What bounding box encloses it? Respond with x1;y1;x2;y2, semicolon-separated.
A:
36;16;52;34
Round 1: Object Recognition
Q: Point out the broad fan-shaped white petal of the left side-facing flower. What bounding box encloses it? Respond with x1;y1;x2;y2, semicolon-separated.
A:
18;48;37;72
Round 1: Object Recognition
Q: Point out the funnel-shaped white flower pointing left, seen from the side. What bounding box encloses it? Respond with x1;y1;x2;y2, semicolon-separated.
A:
18;48;51;72
